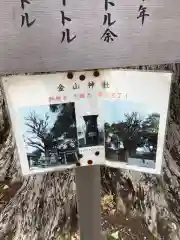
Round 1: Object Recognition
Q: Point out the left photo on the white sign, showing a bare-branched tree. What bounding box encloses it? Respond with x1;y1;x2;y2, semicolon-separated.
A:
20;102;78;169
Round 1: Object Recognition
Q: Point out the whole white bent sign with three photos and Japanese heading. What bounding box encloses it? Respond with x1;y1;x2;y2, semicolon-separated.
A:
2;70;171;175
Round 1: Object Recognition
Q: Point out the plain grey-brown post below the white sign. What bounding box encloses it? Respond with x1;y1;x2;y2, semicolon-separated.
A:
76;166;102;240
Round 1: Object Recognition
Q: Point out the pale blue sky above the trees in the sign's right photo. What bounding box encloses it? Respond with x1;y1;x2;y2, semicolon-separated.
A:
103;100;154;124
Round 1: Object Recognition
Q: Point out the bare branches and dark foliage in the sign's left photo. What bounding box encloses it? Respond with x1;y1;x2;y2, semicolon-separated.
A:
25;103;77;156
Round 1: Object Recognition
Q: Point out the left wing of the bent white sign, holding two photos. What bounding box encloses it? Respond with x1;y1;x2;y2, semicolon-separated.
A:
2;71;105;175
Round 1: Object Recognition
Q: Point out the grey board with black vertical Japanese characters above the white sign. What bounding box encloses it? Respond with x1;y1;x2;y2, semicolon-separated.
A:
0;0;180;74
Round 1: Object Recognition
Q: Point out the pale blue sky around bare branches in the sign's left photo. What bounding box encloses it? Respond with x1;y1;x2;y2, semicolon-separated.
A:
19;105;58;153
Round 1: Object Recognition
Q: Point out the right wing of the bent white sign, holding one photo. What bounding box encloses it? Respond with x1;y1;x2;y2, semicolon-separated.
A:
103;71;171;173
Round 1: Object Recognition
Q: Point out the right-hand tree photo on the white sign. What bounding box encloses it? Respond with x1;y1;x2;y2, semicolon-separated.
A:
104;101;160;168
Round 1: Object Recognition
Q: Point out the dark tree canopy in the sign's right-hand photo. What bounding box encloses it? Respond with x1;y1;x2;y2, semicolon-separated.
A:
105;112;160;152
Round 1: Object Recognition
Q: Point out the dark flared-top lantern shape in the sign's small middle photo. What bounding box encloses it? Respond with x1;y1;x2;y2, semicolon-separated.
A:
83;115;99;146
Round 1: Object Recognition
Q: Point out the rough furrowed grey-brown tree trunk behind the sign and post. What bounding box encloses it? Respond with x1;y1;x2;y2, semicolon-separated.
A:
0;64;180;240
